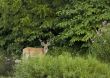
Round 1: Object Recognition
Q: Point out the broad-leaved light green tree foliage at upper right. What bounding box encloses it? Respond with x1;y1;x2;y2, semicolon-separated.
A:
57;0;110;45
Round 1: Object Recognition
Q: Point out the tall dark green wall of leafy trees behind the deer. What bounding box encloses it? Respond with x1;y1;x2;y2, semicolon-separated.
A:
0;0;110;54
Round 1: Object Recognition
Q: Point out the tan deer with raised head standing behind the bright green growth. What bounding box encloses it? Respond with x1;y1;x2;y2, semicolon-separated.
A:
23;39;50;58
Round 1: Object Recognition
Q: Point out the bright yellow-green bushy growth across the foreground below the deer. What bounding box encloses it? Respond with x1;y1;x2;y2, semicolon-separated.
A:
15;54;110;78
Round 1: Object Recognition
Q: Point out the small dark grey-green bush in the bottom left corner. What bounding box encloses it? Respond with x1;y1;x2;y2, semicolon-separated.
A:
0;55;14;78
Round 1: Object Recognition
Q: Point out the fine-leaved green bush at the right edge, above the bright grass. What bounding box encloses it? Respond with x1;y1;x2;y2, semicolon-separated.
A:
89;26;110;62
